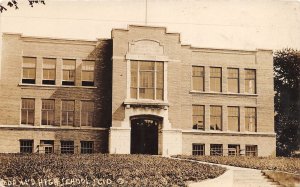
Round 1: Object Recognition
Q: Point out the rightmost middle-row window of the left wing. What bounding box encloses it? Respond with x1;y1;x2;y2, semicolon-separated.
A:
81;101;94;126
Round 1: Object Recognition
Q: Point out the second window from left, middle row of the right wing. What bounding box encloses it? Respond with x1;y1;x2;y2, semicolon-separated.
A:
210;106;222;130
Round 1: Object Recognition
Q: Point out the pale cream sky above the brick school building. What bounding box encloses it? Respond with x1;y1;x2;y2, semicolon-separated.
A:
0;0;300;50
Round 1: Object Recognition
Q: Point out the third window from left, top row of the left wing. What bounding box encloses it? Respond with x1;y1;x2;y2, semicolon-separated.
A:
62;59;76;86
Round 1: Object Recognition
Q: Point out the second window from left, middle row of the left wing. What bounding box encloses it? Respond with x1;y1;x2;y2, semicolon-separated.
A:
42;99;55;125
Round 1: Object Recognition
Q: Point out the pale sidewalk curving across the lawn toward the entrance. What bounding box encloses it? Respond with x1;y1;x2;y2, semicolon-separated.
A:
173;158;280;187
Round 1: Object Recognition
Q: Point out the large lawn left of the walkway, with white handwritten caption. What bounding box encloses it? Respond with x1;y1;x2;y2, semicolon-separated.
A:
0;154;225;186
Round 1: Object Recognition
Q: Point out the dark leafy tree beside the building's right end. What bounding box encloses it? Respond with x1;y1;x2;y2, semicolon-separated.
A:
274;49;300;156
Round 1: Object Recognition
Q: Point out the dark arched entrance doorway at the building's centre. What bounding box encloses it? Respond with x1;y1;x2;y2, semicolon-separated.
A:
130;116;162;155
